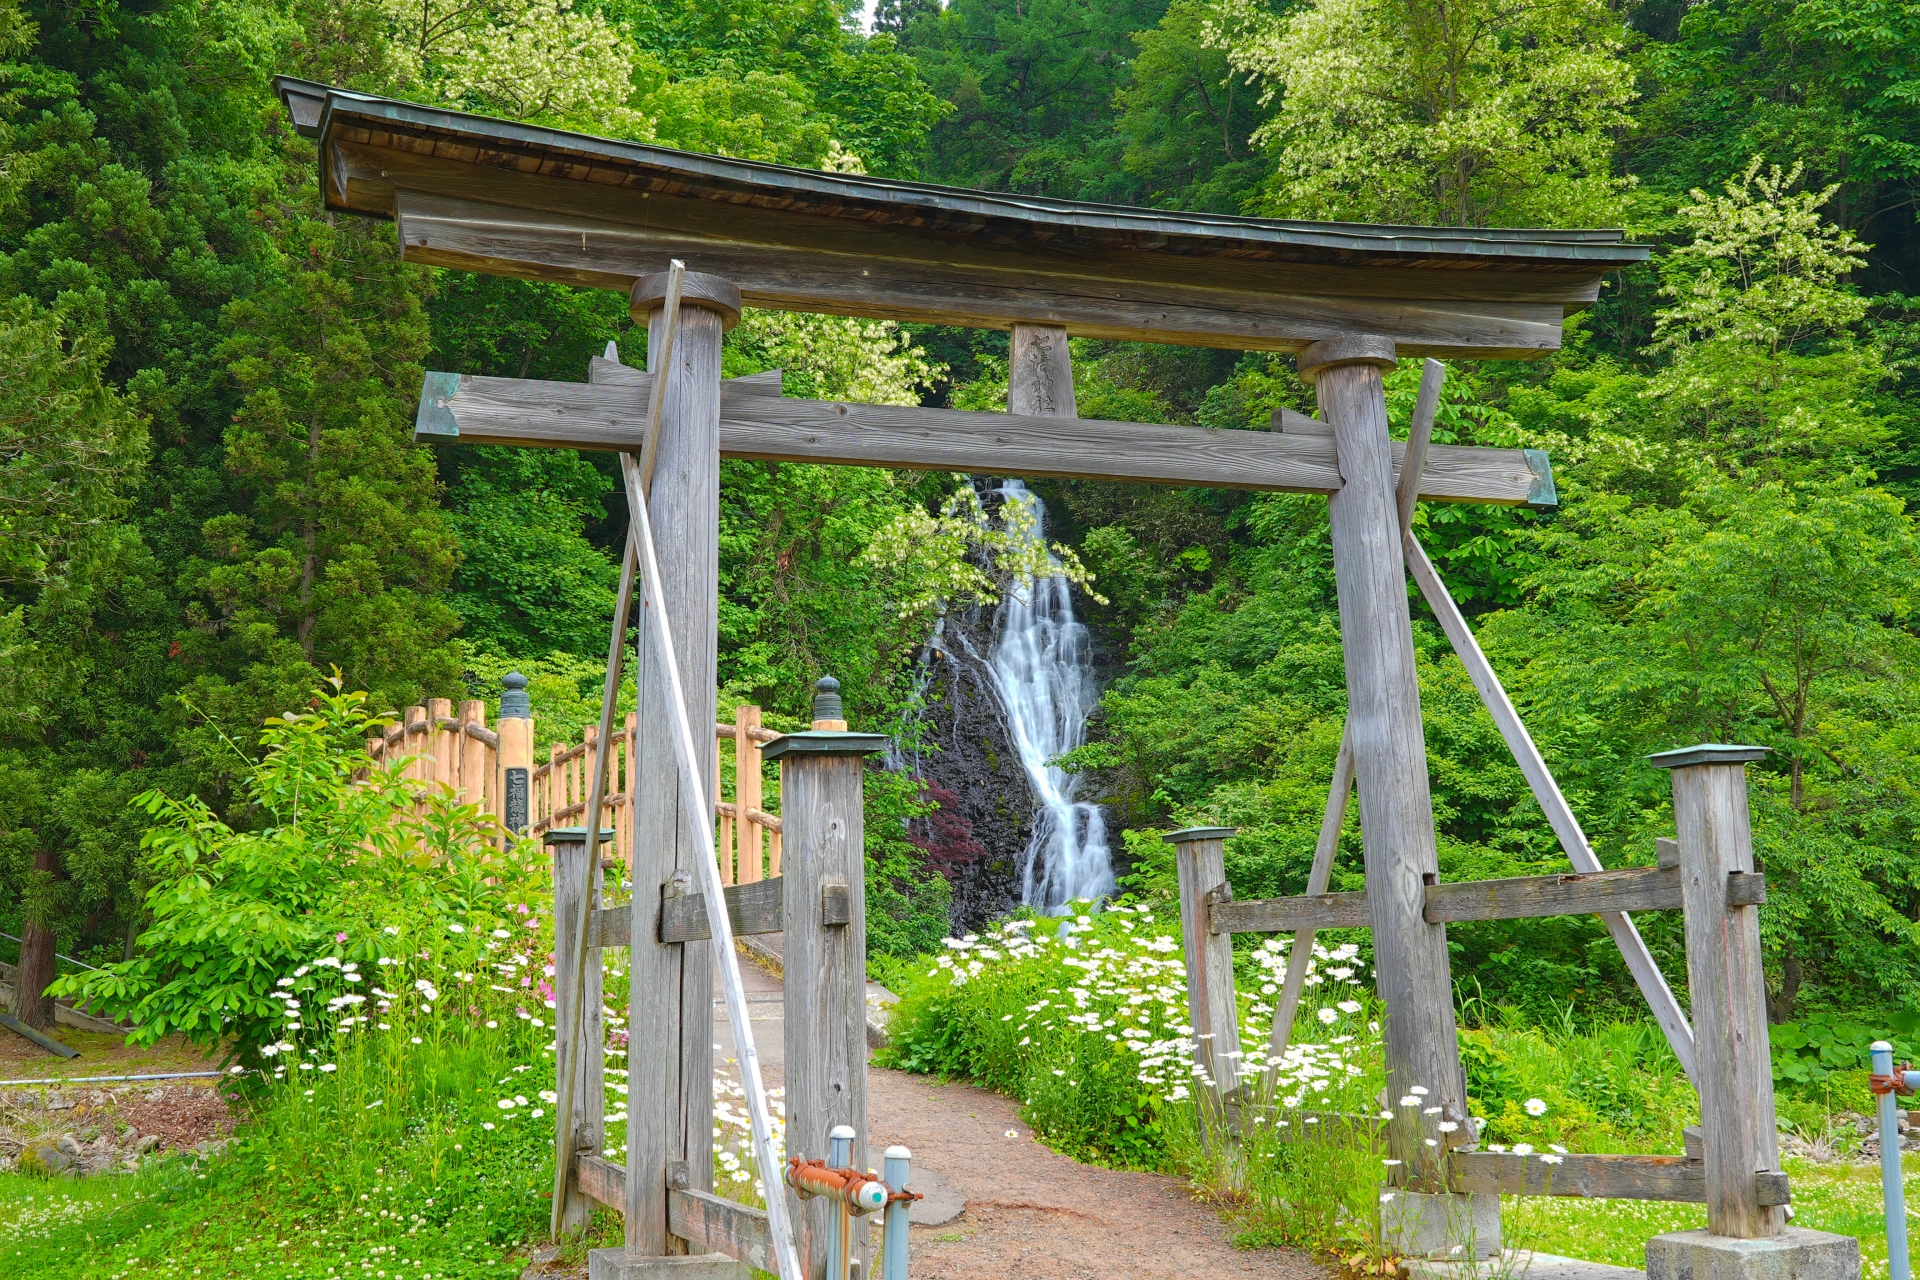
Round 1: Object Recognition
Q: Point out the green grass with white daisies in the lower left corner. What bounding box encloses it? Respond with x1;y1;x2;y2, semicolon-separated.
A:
0;910;618;1280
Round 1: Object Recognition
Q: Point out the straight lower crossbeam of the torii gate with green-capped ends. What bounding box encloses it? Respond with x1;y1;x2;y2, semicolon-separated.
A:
415;372;1553;505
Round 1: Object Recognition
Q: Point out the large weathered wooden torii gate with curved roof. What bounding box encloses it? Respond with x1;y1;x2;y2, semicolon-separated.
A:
275;77;1857;1276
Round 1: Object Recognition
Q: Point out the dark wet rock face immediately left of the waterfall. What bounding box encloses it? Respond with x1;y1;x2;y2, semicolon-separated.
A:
910;610;1035;933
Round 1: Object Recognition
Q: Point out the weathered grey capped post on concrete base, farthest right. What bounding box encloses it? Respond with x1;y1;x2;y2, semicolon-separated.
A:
1653;748;1786;1240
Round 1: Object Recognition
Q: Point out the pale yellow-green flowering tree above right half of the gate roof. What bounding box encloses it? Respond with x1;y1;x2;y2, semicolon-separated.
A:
1204;0;1634;226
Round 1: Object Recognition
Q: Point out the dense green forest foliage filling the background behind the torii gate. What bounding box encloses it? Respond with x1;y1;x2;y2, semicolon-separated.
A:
0;0;1920;1043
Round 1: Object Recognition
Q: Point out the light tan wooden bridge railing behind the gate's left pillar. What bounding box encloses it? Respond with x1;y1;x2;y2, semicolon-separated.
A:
367;681;781;885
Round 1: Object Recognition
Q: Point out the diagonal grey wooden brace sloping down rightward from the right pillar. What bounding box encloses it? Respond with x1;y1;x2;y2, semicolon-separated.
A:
1402;532;1699;1084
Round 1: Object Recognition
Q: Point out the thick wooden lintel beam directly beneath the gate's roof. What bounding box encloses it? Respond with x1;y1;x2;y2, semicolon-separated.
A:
388;185;1592;359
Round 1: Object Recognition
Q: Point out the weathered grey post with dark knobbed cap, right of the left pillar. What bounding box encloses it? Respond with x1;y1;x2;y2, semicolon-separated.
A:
764;677;887;1280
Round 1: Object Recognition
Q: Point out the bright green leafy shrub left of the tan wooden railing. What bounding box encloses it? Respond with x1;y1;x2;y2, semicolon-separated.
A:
54;677;543;1065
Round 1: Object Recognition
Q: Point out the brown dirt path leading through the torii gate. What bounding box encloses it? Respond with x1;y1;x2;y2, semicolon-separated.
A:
714;948;1325;1280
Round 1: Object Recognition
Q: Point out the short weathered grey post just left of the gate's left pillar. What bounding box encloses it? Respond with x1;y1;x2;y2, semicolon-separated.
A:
543;827;614;1230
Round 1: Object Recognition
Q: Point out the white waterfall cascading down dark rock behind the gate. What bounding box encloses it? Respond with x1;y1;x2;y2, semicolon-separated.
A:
987;480;1114;912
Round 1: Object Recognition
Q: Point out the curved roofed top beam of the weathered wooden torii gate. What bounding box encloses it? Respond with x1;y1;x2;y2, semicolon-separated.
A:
275;77;1647;359
